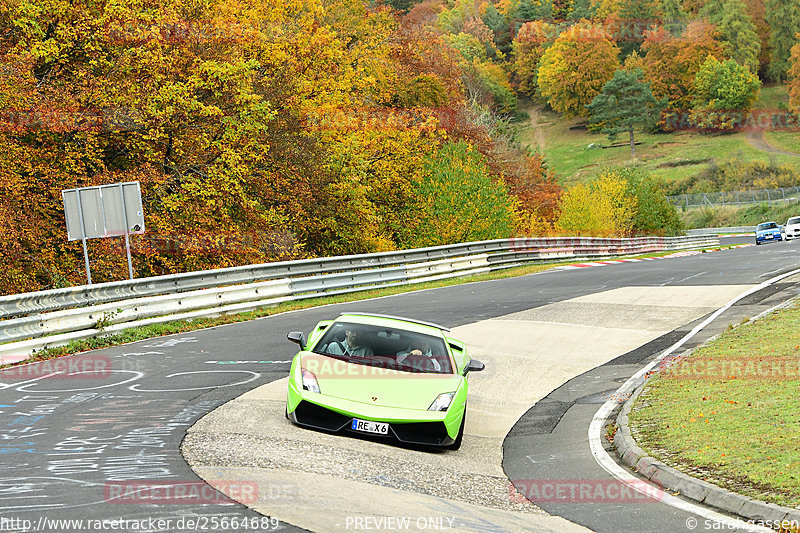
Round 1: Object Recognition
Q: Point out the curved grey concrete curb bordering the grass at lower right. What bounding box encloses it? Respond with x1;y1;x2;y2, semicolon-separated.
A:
614;372;800;527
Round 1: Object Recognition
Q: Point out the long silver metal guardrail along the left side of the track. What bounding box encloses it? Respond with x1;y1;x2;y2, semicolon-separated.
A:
0;235;719;356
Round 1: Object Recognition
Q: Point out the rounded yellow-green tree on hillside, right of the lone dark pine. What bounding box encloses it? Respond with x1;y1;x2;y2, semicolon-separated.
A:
692;57;761;130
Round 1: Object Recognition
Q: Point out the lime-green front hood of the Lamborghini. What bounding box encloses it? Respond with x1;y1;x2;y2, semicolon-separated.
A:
301;354;464;410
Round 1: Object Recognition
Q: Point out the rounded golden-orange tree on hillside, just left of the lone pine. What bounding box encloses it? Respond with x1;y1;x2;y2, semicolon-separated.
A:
537;22;619;116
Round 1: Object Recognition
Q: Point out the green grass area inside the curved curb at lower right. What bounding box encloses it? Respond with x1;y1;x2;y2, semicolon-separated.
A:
630;303;800;507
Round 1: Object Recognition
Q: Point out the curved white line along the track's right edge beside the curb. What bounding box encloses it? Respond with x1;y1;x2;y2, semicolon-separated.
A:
589;269;800;533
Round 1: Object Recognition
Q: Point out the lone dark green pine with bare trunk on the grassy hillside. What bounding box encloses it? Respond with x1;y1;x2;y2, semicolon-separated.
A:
586;68;667;158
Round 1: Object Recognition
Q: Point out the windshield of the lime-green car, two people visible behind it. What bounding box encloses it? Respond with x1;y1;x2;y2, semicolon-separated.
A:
312;322;453;374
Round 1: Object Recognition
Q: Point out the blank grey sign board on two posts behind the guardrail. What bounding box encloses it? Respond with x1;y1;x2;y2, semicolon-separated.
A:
61;181;144;285
